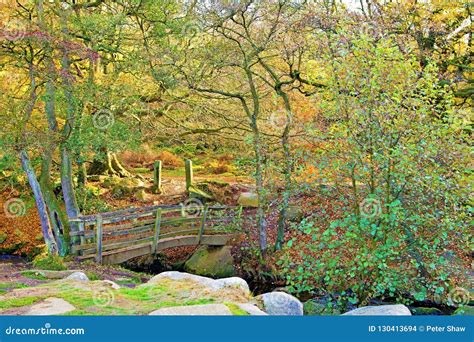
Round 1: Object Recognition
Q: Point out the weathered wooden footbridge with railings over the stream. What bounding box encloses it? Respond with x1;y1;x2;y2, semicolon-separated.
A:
70;203;242;264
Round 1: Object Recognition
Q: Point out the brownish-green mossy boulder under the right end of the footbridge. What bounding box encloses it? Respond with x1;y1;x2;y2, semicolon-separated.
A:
184;246;235;278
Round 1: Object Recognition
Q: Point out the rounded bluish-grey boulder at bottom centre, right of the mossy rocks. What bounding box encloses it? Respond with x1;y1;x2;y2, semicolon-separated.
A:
255;292;303;316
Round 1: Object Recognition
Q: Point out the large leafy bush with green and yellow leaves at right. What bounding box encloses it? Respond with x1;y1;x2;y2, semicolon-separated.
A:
280;32;471;307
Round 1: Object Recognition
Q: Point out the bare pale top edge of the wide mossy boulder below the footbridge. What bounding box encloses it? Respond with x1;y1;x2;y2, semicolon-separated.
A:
147;271;250;294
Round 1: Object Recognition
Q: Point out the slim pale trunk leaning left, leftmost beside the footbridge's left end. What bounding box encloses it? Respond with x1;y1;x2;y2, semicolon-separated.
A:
20;150;58;254
